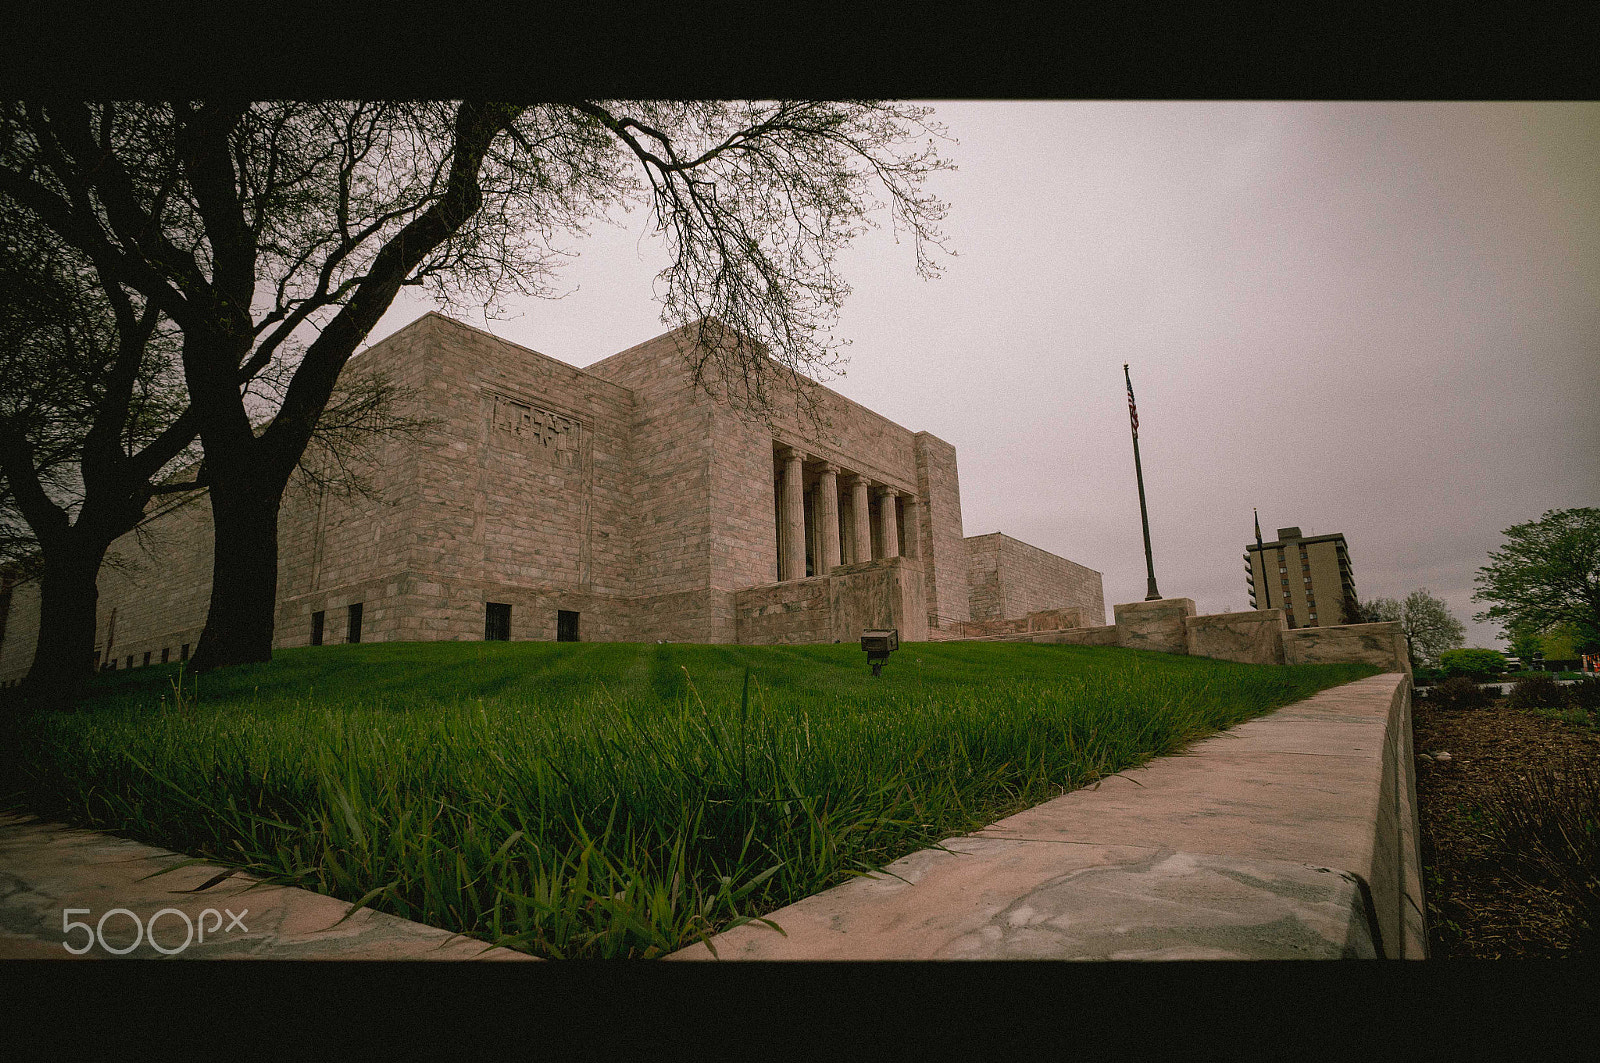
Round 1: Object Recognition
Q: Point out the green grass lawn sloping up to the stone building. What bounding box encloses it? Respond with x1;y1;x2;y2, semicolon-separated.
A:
0;642;1378;957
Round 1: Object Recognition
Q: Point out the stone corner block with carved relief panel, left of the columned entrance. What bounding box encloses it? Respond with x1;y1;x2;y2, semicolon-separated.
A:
274;314;632;645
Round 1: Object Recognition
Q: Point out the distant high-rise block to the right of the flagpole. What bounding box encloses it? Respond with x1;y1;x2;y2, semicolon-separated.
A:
1245;528;1360;628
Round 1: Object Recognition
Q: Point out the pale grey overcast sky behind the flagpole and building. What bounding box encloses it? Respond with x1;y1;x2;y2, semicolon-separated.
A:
371;101;1600;647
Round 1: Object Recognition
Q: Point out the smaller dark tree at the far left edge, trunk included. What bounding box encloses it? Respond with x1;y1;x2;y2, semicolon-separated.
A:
0;205;197;703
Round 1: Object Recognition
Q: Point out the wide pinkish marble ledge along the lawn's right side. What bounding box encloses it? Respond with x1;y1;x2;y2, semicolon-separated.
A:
669;674;1427;959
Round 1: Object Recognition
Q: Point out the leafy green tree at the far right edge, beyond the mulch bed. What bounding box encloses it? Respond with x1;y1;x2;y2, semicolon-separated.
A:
1472;507;1600;653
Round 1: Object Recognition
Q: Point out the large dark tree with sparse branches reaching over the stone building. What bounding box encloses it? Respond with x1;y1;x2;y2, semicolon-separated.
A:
0;101;946;669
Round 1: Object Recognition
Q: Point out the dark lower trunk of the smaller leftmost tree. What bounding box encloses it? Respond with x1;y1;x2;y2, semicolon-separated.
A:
26;535;110;709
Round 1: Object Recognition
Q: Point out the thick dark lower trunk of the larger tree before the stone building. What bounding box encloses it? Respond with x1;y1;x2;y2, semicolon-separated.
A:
192;477;283;672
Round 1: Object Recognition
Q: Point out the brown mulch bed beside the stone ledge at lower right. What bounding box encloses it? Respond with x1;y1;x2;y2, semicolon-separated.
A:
1411;685;1600;959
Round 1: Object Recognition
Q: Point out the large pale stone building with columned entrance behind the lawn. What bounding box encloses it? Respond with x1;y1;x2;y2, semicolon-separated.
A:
0;314;1106;682
